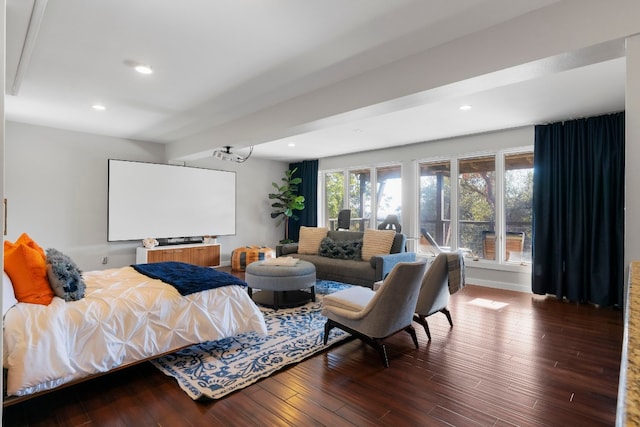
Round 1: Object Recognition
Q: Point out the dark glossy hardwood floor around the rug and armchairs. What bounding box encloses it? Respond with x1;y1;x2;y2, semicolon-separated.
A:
3;286;623;427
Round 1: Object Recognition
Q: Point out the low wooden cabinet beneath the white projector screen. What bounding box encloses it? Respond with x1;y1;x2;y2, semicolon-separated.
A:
136;243;220;267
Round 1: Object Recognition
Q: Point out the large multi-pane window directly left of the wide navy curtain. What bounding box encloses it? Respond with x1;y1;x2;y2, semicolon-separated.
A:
418;150;533;263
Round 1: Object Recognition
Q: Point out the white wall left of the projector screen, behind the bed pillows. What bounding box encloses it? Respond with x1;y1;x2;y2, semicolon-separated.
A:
5;122;164;270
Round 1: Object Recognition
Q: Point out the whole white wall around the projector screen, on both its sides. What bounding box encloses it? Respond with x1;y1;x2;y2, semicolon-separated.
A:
5;122;286;270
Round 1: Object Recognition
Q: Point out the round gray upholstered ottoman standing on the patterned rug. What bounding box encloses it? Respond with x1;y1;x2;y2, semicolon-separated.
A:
244;258;316;310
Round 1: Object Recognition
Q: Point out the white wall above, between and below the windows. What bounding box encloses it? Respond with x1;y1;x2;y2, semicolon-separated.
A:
319;126;534;292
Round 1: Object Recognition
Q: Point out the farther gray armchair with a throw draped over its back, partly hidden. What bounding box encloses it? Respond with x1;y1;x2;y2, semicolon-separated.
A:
414;252;462;341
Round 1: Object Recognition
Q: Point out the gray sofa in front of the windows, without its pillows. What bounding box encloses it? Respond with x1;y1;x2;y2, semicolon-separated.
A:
276;231;416;288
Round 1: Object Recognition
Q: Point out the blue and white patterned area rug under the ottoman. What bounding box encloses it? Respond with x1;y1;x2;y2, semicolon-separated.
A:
151;280;350;400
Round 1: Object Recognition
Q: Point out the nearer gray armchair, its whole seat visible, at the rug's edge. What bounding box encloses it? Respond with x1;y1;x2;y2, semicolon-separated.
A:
322;259;426;368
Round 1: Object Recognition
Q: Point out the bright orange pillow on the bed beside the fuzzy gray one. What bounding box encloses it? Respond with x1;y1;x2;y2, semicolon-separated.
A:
4;235;53;305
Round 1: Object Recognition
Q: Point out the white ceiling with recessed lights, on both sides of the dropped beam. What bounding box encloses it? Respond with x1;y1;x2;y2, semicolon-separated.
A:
5;0;625;161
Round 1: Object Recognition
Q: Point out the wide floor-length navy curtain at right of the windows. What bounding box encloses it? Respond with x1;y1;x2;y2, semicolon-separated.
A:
532;112;624;306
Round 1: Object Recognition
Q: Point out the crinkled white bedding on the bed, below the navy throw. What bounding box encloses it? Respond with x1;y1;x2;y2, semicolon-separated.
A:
4;267;267;396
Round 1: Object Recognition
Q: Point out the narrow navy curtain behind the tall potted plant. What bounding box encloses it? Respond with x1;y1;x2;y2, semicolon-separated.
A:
289;160;318;242
